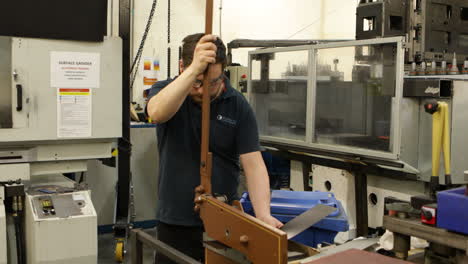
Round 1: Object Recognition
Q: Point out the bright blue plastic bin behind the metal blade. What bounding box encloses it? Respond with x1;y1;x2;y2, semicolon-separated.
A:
240;190;349;247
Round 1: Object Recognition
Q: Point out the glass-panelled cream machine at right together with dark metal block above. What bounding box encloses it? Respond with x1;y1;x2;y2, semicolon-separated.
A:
248;0;468;194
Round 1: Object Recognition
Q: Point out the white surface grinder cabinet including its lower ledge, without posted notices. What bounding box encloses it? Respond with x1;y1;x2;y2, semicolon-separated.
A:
0;37;122;175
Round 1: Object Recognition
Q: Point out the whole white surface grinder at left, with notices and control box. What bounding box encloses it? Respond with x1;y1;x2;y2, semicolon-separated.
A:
0;34;122;263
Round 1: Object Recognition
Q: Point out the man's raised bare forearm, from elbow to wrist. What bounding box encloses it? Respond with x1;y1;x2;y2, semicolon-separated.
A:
148;68;196;123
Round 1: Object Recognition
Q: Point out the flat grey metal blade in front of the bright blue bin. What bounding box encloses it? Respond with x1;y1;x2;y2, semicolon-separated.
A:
281;204;336;239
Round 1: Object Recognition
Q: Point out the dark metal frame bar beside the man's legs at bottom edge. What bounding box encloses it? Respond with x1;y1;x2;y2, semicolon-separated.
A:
130;229;201;264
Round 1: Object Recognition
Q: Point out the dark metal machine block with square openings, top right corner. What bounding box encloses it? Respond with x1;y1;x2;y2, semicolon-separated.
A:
356;0;468;65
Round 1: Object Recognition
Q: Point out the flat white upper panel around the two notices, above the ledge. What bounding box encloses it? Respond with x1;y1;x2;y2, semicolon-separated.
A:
0;37;122;144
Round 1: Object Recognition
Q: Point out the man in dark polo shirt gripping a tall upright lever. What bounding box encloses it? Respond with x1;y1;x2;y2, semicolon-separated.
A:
147;34;282;264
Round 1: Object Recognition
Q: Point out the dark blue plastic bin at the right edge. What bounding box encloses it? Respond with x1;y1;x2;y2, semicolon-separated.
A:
437;187;468;235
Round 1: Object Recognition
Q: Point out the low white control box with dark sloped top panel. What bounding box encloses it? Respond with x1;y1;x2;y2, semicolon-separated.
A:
25;191;97;264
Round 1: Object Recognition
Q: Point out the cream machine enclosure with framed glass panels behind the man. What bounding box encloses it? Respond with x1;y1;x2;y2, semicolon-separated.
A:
248;37;468;184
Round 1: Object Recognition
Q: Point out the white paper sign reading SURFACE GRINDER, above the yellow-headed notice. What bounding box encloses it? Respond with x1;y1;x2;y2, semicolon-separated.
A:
50;51;101;88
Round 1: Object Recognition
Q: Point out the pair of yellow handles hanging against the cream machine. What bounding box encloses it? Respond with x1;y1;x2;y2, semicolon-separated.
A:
432;102;450;176
